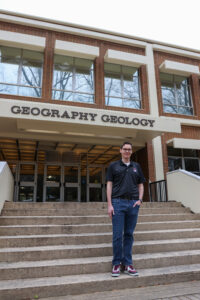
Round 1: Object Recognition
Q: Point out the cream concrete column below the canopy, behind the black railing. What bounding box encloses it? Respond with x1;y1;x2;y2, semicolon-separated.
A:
152;136;164;181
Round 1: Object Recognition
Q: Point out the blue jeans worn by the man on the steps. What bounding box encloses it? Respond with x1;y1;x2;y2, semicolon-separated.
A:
112;198;139;265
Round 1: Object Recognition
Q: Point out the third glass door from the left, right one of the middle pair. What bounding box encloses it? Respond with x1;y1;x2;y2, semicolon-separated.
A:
63;164;81;202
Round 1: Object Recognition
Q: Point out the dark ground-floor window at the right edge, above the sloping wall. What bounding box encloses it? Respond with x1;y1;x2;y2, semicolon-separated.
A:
167;147;200;176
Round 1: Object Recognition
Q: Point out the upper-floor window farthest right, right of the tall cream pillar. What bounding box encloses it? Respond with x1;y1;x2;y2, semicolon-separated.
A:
160;73;193;115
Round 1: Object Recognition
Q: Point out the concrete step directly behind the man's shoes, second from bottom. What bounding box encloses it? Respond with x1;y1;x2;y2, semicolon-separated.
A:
0;250;200;280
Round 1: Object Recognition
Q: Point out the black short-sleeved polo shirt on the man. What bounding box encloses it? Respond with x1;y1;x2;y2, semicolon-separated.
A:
106;160;146;200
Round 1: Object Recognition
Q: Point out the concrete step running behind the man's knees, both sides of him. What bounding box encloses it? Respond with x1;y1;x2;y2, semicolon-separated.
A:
0;228;200;248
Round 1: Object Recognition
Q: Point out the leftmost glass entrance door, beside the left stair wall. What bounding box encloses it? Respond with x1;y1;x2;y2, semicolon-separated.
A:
15;162;37;202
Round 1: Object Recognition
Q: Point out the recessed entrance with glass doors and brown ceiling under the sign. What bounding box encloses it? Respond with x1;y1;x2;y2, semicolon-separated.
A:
0;138;120;202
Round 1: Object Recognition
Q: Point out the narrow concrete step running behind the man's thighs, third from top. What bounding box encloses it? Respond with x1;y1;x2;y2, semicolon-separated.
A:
0;213;199;225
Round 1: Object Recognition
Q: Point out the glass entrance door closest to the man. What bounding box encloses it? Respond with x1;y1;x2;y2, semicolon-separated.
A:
87;165;106;202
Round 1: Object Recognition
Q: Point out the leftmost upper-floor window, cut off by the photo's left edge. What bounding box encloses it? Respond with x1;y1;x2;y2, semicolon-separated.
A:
0;46;43;97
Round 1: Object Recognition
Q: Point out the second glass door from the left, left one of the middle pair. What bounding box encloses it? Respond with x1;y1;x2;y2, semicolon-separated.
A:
43;164;63;202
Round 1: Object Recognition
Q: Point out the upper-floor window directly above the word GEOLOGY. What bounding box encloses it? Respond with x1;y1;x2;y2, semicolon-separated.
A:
104;63;141;109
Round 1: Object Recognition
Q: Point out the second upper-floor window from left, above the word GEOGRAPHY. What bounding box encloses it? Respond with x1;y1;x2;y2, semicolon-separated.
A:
52;55;94;103
